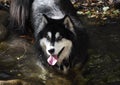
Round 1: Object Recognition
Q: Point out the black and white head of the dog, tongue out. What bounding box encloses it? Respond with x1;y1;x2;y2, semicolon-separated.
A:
38;16;75;68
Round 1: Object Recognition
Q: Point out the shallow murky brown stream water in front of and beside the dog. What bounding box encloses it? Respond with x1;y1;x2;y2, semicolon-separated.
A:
0;9;120;85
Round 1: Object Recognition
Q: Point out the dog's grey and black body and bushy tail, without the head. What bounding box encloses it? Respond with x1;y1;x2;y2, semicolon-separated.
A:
10;0;88;73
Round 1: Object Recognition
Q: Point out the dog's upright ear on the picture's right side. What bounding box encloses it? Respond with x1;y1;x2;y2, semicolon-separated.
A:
63;15;74;32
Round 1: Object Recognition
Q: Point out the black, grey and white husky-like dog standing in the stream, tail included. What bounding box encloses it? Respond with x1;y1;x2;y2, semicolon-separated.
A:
10;0;88;73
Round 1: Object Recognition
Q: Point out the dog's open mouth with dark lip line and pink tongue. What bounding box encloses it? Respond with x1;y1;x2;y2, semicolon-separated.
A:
47;47;65;66
